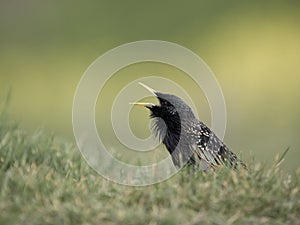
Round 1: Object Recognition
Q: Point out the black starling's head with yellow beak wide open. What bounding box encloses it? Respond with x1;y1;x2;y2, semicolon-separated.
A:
132;83;195;125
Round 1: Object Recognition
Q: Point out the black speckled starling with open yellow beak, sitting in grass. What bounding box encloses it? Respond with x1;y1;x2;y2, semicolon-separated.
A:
131;82;247;171
